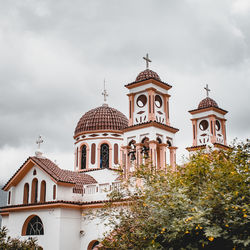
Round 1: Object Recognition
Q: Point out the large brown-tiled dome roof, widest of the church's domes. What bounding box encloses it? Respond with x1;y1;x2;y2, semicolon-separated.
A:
75;104;128;135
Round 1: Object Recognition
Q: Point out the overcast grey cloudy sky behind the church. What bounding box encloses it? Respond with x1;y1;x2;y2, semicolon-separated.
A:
0;0;250;182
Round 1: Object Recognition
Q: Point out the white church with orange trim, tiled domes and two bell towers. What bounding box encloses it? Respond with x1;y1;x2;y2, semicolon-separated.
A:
0;55;227;250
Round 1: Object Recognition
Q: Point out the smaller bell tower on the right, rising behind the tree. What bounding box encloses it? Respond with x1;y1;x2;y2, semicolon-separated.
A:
186;85;228;151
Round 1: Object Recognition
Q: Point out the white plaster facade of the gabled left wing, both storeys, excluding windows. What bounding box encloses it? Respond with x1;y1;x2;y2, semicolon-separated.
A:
2;159;120;250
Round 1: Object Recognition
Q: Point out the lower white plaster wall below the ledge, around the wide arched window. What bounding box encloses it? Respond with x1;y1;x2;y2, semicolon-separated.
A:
2;208;116;250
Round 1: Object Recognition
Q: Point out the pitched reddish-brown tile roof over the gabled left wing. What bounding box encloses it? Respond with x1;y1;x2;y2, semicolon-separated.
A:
3;156;97;193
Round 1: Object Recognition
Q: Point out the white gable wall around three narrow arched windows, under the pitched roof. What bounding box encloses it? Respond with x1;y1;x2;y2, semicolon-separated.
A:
11;166;55;205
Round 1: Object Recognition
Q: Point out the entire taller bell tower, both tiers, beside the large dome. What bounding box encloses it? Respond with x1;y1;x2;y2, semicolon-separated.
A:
123;54;179;176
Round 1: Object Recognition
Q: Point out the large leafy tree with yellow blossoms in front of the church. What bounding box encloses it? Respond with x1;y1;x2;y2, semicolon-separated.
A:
99;140;250;250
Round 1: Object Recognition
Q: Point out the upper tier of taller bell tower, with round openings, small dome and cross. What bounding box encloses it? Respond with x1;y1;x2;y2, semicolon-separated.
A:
128;54;172;126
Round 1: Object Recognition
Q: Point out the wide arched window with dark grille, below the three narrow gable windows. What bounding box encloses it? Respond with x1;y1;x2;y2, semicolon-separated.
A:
22;215;44;235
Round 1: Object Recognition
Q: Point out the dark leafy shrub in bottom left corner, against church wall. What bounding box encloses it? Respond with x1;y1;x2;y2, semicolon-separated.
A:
0;227;43;250
